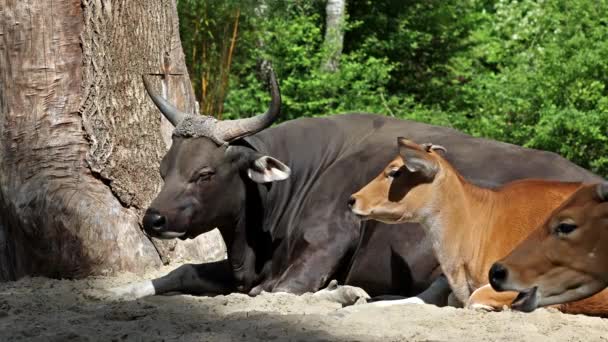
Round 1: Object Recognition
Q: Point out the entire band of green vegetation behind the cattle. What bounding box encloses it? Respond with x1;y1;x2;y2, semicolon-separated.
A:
178;0;608;176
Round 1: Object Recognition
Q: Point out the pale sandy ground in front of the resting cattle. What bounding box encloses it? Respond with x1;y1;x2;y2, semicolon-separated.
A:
0;268;608;342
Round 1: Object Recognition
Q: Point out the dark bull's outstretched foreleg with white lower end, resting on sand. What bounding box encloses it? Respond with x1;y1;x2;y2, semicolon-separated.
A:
108;260;236;299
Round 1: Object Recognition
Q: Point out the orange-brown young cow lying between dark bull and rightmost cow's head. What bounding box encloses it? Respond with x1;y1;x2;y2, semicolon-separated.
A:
349;138;608;313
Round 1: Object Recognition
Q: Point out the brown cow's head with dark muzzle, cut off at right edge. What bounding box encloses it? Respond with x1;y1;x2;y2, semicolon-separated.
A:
489;183;608;315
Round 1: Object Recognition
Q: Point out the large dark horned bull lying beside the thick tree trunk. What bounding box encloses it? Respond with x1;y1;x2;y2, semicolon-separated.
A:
110;70;599;297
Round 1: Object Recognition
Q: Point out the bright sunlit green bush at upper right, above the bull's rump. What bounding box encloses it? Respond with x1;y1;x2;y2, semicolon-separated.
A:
442;0;608;175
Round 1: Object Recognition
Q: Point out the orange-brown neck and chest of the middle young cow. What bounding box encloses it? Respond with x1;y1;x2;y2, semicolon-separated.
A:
420;165;500;300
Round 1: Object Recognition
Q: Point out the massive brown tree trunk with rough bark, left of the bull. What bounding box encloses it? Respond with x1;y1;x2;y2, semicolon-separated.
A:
0;0;223;280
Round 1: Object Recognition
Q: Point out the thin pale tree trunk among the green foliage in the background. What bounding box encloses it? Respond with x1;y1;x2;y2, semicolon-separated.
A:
322;0;346;72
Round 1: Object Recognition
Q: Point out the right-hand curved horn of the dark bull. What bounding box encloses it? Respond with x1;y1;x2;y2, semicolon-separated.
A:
215;69;281;142
